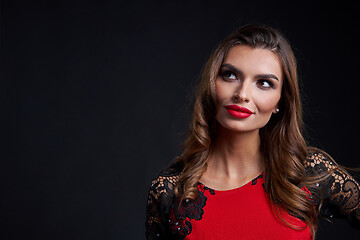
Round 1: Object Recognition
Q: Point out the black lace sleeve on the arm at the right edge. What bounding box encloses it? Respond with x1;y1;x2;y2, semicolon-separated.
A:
305;151;360;228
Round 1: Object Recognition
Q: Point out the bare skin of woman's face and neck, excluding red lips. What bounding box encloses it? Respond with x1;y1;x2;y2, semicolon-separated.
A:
200;45;283;191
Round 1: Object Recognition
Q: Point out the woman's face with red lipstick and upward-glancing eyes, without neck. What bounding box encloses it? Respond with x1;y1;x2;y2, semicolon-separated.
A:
215;45;283;132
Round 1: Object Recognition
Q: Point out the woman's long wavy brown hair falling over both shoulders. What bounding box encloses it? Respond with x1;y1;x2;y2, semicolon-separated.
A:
175;25;318;238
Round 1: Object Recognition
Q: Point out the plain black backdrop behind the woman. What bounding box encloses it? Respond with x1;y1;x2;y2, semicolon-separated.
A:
0;0;360;239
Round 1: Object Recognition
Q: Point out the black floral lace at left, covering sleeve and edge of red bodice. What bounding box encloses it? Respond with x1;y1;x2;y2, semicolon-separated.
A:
146;164;215;239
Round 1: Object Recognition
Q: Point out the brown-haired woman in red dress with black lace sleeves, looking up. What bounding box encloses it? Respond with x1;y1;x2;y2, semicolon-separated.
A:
146;25;360;240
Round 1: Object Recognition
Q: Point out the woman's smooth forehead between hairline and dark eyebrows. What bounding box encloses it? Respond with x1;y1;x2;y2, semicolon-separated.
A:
223;45;283;79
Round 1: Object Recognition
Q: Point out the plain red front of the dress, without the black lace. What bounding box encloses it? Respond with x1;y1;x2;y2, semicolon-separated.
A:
185;175;311;240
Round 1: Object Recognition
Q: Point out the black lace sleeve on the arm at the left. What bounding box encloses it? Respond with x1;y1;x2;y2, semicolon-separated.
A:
145;170;178;240
